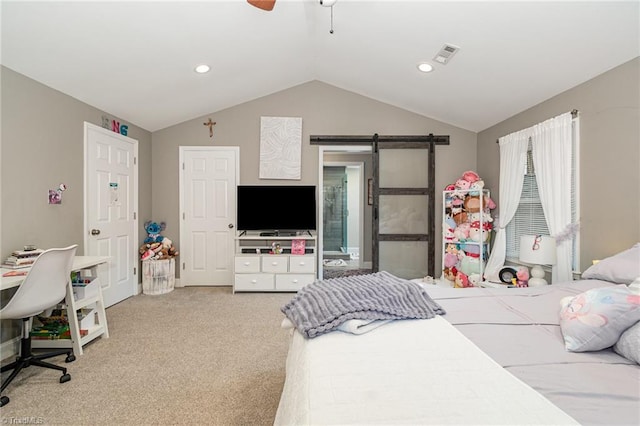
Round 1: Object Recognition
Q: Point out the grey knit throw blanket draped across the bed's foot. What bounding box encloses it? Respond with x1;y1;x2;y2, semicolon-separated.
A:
281;271;445;338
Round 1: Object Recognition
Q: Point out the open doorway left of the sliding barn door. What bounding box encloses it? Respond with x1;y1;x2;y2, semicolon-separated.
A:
318;146;372;278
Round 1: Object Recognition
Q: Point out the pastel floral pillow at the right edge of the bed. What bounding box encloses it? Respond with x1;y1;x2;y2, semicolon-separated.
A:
560;284;640;352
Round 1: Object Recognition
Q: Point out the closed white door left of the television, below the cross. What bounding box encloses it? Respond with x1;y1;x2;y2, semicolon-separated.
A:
180;147;240;286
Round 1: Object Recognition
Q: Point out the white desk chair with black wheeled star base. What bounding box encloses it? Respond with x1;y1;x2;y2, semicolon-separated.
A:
0;244;78;407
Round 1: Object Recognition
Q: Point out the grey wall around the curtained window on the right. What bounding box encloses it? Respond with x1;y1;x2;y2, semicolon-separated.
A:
478;58;640;271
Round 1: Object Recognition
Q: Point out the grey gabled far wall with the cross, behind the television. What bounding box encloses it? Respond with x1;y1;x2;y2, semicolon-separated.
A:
152;81;476;276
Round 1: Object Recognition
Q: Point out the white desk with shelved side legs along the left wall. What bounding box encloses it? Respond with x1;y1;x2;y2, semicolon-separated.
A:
0;256;111;355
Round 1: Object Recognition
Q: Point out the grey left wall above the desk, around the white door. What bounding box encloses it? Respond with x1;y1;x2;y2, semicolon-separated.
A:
0;67;151;259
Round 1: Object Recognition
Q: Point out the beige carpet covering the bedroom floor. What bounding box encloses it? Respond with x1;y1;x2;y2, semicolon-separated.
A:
0;287;293;425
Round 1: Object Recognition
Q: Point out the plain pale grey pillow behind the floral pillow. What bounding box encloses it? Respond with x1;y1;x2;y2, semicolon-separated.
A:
582;243;640;284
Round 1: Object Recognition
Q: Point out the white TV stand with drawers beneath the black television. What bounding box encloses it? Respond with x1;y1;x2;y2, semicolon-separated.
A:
233;232;317;293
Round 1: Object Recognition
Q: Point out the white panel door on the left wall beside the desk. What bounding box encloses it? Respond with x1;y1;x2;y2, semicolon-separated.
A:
84;123;138;306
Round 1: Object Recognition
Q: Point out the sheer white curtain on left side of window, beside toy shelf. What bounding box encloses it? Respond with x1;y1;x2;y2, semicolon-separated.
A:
485;129;531;281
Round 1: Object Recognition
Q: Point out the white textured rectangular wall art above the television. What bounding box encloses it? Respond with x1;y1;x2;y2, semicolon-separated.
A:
259;117;302;179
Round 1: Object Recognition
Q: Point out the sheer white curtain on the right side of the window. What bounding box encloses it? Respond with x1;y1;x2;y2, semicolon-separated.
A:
532;112;573;283
